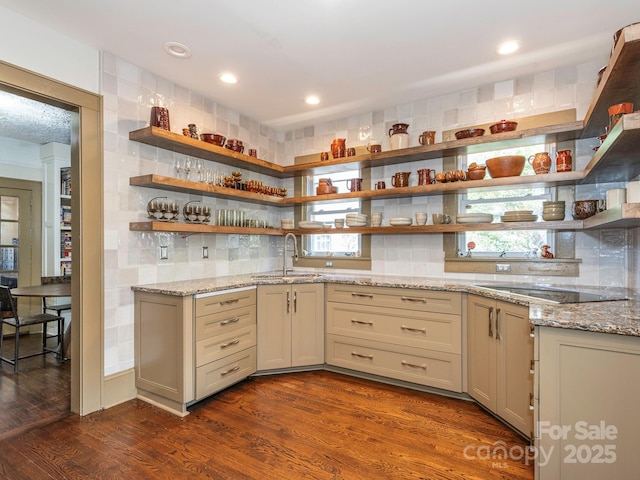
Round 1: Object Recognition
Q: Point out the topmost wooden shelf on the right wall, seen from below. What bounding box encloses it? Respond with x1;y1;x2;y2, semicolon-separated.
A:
582;24;640;138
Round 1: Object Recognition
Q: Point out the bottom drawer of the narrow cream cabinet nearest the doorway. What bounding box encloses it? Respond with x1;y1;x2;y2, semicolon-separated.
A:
196;347;256;400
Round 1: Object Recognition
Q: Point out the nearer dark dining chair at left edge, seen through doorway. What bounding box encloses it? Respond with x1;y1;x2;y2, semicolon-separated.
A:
0;285;64;373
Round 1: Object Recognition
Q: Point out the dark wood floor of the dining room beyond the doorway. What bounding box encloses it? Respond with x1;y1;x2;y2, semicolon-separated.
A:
0;335;71;439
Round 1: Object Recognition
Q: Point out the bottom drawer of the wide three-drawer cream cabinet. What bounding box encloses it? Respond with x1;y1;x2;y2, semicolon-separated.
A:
327;335;462;392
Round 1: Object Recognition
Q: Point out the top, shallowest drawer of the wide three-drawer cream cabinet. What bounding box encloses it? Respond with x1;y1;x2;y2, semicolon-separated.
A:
327;284;462;315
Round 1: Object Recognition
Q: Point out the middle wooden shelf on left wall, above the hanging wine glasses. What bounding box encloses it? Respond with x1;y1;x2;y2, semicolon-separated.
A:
129;174;284;206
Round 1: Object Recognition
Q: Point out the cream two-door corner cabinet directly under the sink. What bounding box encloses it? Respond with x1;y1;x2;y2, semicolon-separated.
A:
258;283;324;371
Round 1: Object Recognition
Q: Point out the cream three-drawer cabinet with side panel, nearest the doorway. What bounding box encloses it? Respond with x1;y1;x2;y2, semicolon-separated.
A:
134;287;256;415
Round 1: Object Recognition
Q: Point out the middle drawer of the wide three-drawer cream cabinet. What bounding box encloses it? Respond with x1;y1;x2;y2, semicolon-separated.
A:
327;302;462;353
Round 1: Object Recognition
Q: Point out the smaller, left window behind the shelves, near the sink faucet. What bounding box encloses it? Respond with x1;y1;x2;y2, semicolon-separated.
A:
303;170;363;257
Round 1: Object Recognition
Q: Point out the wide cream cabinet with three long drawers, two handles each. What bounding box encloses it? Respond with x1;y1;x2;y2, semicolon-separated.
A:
327;284;462;392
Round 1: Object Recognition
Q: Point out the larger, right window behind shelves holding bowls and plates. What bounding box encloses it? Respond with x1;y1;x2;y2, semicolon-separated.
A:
458;144;554;257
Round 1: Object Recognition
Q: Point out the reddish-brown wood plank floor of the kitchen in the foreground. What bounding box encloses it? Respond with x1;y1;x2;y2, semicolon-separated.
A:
0;371;533;480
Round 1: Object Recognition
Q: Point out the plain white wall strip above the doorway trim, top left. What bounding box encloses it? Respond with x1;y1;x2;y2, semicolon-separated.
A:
0;7;100;93
